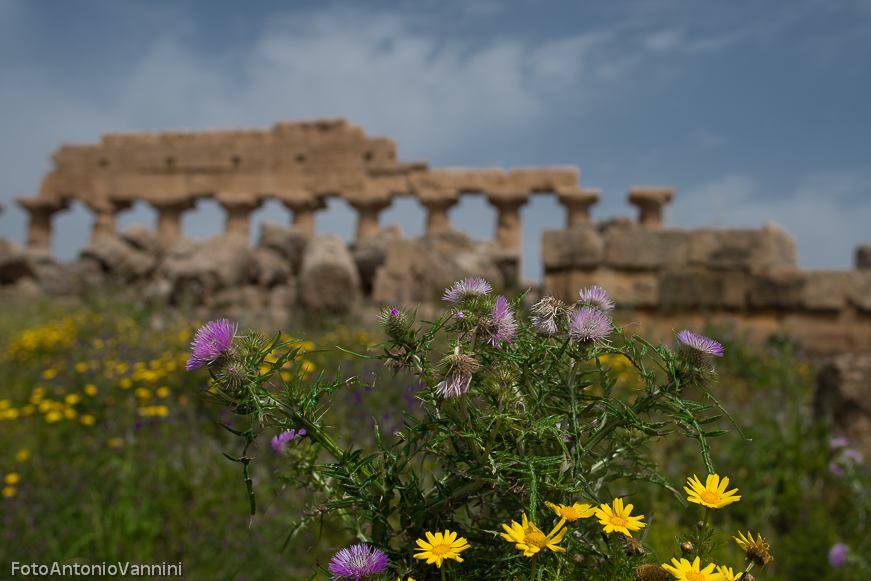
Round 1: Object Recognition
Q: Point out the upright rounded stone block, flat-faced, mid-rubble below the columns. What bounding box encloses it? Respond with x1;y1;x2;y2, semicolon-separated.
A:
298;235;362;311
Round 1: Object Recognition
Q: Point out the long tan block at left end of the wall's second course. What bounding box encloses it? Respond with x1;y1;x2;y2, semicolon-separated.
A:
543;268;659;309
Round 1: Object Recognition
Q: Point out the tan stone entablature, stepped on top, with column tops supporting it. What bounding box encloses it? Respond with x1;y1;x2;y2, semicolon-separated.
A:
17;120;584;257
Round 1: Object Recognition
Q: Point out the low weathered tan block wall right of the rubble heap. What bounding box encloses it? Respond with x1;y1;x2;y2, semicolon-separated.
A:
542;212;871;353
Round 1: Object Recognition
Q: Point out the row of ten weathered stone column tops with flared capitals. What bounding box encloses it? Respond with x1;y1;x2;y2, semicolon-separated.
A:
16;188;673;252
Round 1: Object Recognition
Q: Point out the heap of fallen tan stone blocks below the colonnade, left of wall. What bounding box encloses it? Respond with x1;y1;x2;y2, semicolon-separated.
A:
0;223;517;311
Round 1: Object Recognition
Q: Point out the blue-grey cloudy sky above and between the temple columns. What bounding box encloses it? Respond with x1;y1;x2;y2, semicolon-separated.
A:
0;0;871;281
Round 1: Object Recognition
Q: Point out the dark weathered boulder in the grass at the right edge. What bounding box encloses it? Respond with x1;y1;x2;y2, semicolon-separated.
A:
814;353;871;458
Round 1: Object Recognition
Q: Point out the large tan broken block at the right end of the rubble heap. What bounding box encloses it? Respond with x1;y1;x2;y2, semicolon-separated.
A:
372;231;504;305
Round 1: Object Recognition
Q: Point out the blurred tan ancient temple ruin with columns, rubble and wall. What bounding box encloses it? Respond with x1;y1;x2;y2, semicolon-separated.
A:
0;120;871;352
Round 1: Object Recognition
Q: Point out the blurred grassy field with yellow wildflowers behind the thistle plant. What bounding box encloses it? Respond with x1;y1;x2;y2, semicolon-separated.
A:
0;288;871;581
